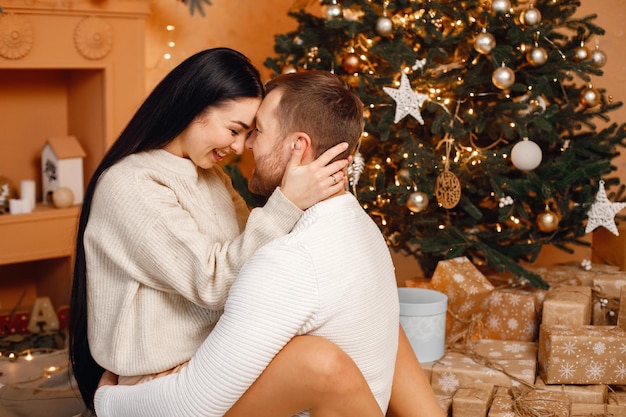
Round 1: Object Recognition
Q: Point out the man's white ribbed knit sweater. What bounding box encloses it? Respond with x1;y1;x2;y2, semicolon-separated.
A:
95;194;399;417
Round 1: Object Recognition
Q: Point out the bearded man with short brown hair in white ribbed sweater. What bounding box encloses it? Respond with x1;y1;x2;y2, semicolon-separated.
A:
96;71;441;417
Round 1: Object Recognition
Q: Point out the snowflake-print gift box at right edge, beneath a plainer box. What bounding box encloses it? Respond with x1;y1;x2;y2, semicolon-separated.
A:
538;324;626;384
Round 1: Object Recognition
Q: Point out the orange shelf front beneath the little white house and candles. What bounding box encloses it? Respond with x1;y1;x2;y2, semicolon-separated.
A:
0;205;80;265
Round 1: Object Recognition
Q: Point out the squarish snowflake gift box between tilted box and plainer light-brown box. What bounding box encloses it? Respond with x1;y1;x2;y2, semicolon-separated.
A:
480;288;541;342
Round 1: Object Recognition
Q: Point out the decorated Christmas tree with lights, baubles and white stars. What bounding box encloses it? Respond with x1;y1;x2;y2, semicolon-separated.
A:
255;0;626;287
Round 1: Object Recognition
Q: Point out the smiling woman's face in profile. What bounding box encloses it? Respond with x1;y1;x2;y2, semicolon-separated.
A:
164;98;261;169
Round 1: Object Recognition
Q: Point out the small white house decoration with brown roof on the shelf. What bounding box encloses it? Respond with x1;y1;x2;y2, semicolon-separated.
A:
41;136;86;204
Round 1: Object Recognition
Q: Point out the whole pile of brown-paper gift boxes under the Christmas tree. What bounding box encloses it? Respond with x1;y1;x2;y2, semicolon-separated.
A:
406;257;626;417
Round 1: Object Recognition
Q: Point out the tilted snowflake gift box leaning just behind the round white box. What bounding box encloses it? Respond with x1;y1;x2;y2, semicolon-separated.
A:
431;256;494;340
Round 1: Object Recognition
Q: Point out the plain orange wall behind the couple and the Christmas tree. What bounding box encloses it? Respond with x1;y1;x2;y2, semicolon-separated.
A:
146;0;626;282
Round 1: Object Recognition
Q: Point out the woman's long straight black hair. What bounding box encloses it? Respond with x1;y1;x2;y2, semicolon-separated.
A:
69;48;263;411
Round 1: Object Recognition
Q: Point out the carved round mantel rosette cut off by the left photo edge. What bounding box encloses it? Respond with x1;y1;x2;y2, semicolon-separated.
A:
0;13;33;59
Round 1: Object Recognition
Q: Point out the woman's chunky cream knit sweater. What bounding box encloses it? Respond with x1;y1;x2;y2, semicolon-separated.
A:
84;150;302;375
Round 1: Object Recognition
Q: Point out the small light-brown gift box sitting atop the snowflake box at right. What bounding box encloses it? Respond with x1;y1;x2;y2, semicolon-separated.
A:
541;286;591;326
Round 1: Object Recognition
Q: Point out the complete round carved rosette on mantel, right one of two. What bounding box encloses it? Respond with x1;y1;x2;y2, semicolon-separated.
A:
74;16;113;60
